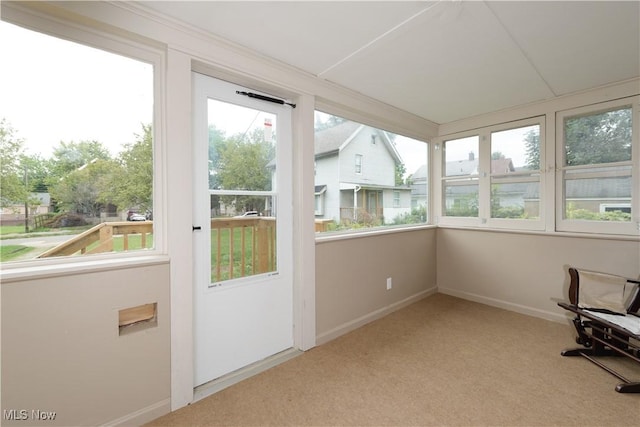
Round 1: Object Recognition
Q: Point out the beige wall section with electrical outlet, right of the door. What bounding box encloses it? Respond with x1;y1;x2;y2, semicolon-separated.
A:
316;228;436;343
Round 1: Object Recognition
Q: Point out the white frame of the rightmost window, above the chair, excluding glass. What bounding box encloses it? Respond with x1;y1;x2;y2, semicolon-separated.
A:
555;96;640;236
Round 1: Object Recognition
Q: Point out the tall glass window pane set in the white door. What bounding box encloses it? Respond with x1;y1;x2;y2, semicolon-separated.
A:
207;99;277;283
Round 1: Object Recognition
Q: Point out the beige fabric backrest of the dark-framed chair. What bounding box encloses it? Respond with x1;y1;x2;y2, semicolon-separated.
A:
569;267;640;314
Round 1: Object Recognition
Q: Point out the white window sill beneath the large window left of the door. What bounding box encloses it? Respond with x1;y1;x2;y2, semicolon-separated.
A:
0;255;169;285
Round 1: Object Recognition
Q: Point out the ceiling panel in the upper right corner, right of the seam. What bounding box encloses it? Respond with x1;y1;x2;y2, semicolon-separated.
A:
489;1;640;95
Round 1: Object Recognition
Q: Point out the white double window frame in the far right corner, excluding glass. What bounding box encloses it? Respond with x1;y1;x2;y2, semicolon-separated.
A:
433;115;546;231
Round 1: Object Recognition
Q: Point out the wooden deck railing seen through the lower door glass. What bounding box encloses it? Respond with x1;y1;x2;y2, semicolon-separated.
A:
211;217;276;282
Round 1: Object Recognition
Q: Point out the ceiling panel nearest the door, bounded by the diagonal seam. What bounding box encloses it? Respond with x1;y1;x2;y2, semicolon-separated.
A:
143;1;431;75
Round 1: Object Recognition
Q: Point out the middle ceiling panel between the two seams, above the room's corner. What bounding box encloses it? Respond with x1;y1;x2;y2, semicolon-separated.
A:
323;2;553;123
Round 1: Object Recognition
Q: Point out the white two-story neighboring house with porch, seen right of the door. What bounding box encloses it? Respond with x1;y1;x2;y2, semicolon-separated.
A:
315;121;411;224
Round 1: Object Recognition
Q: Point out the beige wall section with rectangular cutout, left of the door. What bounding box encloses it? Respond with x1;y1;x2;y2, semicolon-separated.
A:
1;260;171;426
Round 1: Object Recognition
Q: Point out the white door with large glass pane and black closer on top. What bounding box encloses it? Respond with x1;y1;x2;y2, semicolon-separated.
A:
191;73;293;386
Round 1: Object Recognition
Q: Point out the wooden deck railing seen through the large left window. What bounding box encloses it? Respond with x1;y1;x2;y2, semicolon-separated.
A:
38;221;153;258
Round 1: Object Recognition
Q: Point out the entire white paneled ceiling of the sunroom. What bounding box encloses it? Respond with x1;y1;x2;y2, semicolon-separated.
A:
141;0;640;123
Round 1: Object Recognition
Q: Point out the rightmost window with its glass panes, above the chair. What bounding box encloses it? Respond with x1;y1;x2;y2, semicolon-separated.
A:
557;98;639;234
